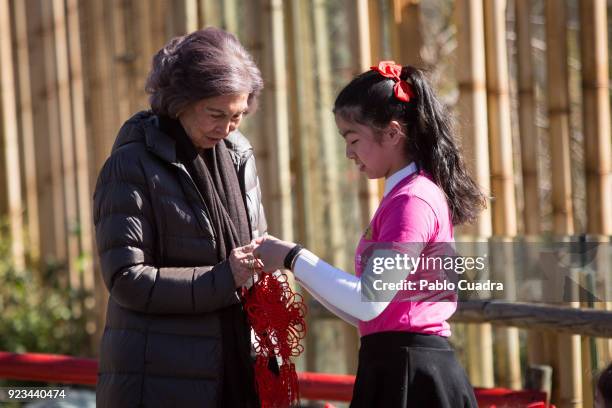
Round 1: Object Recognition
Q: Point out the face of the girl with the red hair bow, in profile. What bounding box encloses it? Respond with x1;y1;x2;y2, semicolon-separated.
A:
336;115;408;179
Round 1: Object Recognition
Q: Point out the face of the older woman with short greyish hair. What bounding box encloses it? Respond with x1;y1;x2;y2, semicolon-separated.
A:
178;93;249;149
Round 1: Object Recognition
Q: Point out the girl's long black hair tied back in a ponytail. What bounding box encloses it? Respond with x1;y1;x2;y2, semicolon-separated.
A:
334;66;486;225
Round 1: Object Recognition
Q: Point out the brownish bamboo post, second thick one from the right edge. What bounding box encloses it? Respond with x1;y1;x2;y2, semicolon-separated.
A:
546;0;582;408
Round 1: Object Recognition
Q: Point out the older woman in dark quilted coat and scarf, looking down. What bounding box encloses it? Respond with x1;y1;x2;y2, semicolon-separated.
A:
94;28;266;408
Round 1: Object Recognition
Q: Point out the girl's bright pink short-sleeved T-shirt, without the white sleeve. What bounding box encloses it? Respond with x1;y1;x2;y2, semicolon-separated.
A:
355;167;457;336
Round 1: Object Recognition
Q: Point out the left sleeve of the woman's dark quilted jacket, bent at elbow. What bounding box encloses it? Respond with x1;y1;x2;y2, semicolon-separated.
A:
94;145;237;314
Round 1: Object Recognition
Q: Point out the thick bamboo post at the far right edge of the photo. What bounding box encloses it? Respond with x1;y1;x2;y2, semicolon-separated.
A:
580;0;612;398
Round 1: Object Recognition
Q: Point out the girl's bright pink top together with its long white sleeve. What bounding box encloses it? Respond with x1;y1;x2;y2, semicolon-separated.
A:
293;163;457;336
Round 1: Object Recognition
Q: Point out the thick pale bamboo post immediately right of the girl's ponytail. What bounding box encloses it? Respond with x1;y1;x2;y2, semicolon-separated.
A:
455;0;494;387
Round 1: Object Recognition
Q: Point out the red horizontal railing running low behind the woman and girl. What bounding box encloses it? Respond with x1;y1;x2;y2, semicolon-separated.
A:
0;352;546;408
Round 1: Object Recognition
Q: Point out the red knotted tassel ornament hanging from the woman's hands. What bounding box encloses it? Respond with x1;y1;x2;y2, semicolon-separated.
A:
244;266;306;408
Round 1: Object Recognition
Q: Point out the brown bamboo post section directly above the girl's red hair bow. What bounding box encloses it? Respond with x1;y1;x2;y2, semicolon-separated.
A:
390;0;425;68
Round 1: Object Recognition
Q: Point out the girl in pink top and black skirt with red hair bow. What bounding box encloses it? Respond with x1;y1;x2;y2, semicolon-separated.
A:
254;61;485;408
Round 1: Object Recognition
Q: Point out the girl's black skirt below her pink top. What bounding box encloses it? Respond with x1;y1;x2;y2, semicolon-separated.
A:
350;332;478;408
